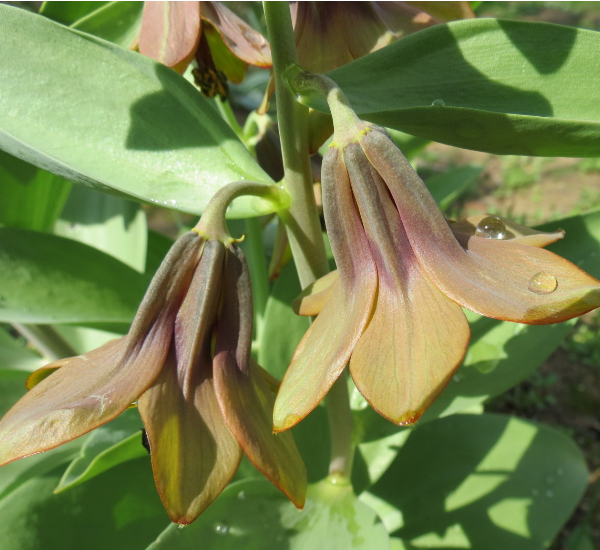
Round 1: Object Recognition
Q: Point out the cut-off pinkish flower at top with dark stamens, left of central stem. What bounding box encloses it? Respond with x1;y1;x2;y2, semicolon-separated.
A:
137;2;273;98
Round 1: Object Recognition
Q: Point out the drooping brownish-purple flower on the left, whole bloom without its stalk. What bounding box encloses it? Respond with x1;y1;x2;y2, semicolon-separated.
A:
0;231;306;524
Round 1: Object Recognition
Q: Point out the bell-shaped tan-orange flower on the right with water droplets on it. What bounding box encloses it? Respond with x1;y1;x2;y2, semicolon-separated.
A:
274;96;600;431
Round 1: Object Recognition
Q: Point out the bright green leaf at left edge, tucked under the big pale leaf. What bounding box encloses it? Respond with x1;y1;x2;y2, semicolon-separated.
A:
0;151;72;231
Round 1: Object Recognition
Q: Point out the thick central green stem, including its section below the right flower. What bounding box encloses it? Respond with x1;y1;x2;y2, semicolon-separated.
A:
264;2;354;477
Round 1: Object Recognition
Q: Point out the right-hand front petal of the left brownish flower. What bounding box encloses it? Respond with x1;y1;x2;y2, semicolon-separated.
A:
213;248;306;508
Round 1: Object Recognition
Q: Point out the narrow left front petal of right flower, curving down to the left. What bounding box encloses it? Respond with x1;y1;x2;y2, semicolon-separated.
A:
273;147;377;432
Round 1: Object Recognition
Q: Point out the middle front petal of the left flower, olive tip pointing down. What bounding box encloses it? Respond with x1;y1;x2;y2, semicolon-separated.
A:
138;240;242;524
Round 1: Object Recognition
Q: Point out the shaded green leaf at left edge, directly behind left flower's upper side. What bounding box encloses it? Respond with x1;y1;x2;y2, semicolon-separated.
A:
0;228;148;332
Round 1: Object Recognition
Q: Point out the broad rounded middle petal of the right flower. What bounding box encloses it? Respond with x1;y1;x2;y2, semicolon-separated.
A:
344;144;470;425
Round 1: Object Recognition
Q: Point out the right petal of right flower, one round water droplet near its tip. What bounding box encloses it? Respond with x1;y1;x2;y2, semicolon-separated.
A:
360;131;600;324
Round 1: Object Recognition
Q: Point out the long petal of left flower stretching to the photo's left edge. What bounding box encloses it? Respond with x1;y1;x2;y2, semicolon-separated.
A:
0;232;202;465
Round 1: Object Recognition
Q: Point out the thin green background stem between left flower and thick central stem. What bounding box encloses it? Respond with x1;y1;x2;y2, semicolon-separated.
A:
246;218;269;339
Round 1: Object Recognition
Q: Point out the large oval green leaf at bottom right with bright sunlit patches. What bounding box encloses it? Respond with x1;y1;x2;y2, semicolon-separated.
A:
366;414;588;550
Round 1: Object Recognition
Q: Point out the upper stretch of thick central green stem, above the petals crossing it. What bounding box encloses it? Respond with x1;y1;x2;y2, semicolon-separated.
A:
264;2;329;288
